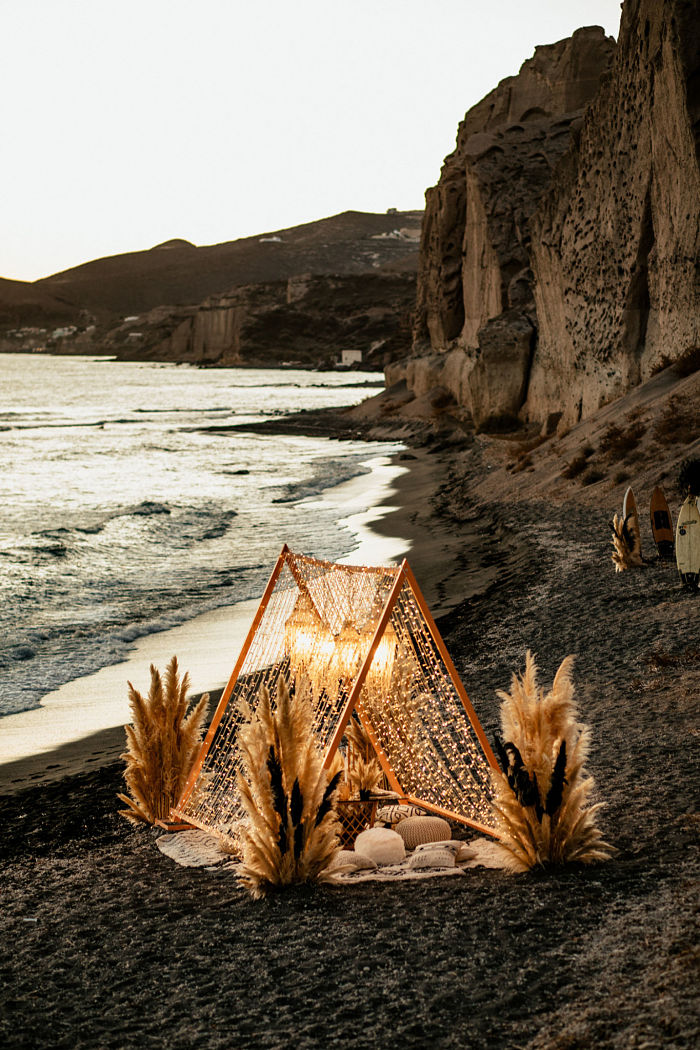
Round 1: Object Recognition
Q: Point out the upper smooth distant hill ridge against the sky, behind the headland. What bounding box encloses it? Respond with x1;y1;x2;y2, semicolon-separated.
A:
30;211;423;321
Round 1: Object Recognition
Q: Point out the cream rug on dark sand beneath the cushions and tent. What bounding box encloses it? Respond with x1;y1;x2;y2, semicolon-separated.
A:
156;830;503;886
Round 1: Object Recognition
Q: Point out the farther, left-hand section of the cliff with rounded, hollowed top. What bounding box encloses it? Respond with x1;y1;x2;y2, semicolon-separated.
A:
413;27;614;424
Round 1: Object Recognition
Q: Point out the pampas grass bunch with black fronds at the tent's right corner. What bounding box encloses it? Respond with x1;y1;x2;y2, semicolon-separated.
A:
492;652;613;872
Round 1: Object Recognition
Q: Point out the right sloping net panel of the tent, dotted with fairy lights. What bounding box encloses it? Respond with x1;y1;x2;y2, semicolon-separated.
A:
360;581;494;826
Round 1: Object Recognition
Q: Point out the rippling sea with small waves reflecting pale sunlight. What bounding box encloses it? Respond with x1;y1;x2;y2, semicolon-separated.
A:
0;354;401;716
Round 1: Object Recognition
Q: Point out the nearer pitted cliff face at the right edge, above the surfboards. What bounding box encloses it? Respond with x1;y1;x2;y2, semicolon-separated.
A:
524;0;700;425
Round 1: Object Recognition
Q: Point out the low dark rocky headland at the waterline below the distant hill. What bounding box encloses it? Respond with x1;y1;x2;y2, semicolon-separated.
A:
103;272;416;369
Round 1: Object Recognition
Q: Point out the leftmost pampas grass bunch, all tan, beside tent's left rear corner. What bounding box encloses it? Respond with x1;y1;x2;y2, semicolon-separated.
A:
119;656;209;824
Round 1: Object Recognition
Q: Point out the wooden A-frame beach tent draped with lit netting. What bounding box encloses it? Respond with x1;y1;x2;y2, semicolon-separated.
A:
171;544;499;835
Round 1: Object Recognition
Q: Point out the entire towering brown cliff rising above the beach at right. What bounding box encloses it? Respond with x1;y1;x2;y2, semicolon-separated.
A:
398;0;700;427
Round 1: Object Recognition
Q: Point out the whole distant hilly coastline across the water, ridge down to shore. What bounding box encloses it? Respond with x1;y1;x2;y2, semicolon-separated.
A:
0;209;422;369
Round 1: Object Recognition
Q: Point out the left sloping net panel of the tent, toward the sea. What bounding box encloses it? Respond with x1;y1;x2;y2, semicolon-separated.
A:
177;552;399;833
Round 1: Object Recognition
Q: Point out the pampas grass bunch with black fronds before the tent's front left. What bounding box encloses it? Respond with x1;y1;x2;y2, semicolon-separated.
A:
238;675;341;898
